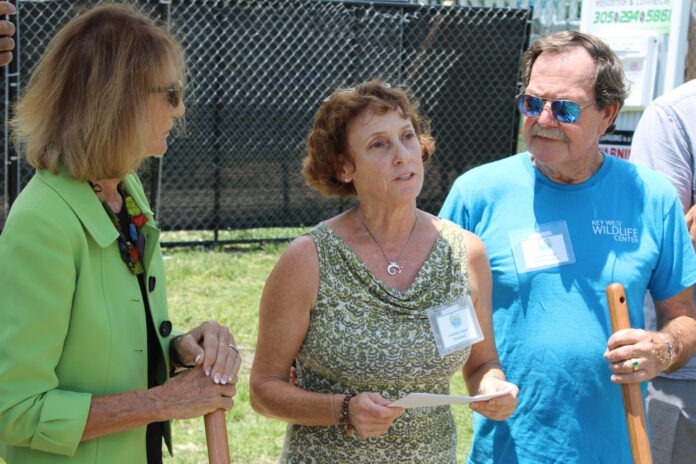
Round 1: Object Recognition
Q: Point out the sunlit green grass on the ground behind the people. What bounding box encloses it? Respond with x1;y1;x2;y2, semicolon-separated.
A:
0;229;471;464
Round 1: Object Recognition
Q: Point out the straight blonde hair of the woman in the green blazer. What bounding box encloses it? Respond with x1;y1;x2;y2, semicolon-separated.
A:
11;4;185;180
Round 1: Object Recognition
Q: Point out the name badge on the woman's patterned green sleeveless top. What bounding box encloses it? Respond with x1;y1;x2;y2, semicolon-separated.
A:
427;295;483;357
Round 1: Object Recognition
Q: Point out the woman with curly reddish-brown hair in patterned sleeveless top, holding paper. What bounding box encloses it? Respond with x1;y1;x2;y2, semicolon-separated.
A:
251;81;518;464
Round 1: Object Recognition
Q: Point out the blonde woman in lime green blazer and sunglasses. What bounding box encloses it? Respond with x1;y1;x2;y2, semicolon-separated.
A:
0;5;240;464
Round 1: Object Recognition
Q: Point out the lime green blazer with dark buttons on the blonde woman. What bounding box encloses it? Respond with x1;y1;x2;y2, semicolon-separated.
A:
0;171;171;464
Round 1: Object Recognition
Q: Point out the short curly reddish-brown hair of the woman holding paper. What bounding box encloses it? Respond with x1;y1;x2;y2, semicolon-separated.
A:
302;80;435;198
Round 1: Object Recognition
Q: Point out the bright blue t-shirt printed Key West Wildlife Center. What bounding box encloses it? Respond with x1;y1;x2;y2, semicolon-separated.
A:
440;153;696;464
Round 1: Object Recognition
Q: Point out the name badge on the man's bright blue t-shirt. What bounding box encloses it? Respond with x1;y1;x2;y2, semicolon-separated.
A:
509;221;575;274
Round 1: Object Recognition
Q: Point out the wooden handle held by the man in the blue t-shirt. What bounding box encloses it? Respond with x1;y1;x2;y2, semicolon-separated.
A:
606;283;652;464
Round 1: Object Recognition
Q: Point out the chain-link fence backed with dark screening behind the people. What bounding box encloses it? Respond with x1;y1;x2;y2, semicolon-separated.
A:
0;0;530;243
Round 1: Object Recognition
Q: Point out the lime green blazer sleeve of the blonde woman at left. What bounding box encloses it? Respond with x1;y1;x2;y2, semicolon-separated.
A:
0;203;91;456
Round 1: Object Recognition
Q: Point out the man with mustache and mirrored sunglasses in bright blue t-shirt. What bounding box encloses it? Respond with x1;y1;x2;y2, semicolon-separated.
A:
440;31;696;464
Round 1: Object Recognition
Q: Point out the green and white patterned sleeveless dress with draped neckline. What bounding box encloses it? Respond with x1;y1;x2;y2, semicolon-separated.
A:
281;220;470;464
